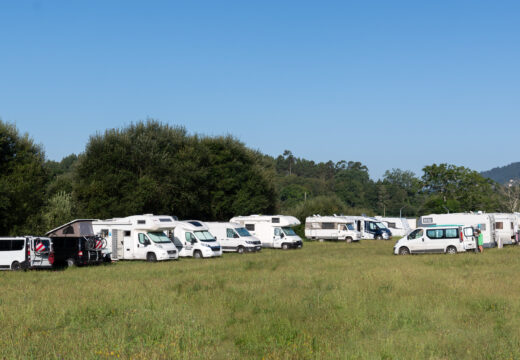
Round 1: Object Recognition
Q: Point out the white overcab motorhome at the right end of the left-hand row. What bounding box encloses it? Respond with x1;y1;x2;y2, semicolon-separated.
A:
229;215;303;249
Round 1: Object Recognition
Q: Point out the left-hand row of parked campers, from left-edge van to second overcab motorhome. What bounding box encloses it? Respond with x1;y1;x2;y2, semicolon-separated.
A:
0;214;303;270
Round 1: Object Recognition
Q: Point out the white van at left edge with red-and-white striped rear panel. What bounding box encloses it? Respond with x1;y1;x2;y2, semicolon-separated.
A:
0;236;54;270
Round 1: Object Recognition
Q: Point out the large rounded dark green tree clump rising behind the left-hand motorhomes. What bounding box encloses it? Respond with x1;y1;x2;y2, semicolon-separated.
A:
75;120;276;220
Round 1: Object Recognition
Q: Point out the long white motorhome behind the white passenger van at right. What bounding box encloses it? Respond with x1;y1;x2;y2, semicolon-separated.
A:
417;211;518;247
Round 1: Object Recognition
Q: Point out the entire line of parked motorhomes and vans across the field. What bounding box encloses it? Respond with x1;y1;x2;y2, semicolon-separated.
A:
4;212;520;270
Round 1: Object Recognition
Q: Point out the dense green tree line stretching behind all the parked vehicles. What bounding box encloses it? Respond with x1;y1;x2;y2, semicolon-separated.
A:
0;120;520;235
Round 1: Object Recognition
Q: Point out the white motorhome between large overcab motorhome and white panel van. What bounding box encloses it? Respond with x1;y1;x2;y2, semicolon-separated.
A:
173;220;222;259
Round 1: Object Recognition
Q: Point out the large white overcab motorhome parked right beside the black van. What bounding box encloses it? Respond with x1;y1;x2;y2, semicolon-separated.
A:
92;214;179;262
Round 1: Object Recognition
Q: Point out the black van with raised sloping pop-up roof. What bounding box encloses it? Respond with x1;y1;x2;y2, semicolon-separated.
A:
45;219;104;266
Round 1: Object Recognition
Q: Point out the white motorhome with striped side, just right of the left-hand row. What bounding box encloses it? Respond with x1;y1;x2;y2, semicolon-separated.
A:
305;215;361;242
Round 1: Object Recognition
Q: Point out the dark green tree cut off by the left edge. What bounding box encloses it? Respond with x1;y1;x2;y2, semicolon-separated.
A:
0;120;48;235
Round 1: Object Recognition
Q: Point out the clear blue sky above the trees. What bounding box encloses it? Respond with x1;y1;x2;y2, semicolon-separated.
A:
0;0;520;178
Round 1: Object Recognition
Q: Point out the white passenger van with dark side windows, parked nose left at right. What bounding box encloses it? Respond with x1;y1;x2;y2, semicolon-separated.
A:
394;225;476;255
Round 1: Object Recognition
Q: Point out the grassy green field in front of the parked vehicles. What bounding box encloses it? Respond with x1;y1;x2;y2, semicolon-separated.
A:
0;240;520;359
